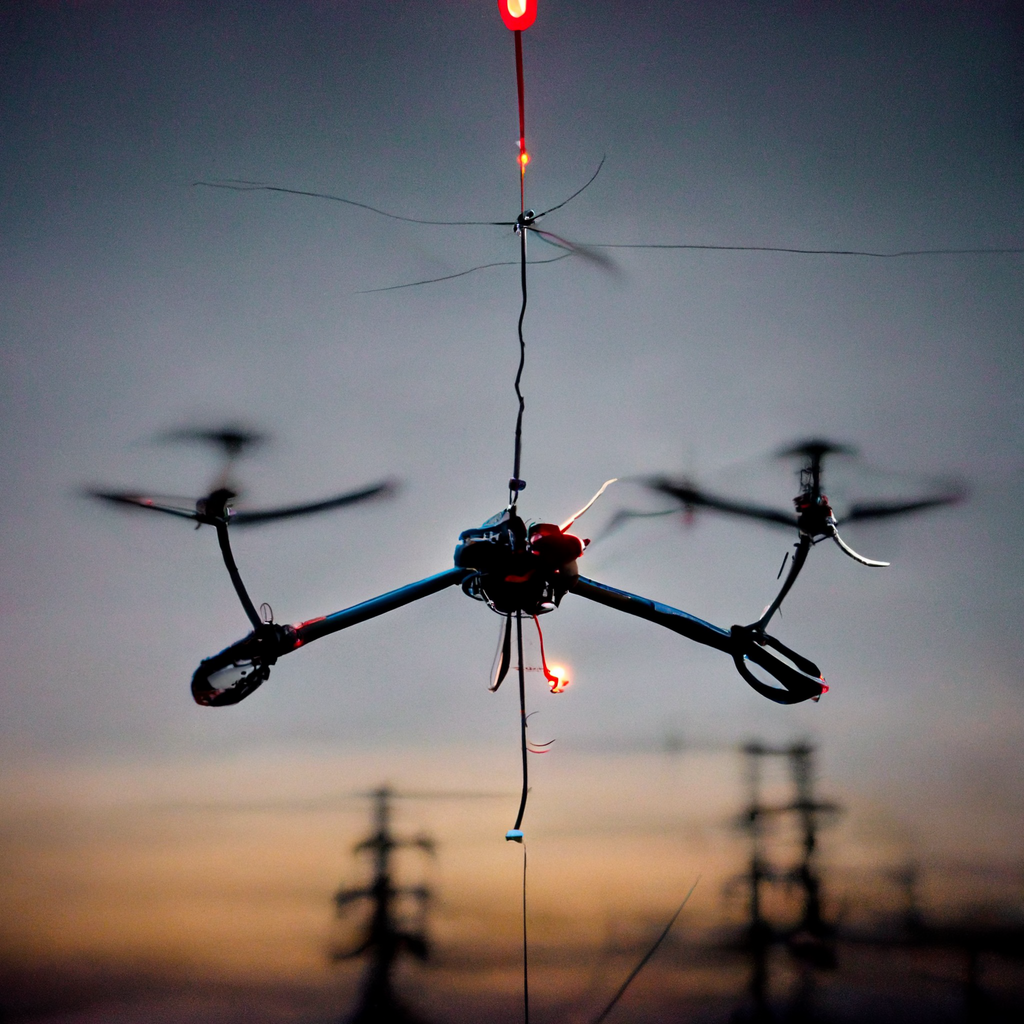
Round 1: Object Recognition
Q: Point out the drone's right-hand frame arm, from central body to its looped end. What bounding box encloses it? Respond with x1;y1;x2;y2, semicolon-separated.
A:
571;577;827;705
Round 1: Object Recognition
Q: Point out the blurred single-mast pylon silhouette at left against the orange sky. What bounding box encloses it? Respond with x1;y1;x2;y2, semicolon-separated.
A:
333;785;434;1024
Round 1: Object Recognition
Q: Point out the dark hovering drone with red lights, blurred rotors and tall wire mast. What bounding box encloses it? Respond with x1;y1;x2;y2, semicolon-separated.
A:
93;0;978;741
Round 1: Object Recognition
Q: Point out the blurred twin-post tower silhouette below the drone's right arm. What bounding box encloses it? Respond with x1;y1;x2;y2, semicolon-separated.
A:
740;742;839;1021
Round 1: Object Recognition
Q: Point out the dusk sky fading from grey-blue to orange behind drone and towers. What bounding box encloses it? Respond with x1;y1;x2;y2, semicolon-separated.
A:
0;0;1024;1021
